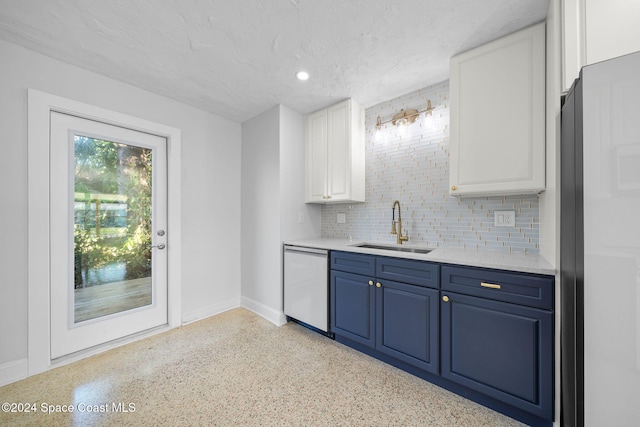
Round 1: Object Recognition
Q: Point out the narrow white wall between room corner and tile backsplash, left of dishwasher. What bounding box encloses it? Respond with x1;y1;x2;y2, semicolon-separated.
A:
241;105;320;324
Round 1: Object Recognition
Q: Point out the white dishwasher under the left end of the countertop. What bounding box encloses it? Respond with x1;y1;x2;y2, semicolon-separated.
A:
284;245;329;334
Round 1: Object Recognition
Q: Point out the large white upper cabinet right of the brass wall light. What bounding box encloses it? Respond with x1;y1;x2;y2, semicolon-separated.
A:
449;23;545;196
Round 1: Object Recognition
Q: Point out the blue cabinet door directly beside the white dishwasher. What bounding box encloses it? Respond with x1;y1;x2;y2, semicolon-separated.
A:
331;270;376;348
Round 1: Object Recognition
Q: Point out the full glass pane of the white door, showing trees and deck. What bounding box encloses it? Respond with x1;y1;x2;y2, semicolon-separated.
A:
73;135;153;323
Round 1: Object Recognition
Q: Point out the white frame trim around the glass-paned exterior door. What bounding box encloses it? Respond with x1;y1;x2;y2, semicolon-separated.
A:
27;89;182;376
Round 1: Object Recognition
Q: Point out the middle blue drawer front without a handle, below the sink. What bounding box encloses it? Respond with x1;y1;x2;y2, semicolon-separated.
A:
376;257;440;289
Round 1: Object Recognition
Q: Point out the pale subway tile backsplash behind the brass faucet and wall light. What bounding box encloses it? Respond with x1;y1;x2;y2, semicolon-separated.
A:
321;81;539;253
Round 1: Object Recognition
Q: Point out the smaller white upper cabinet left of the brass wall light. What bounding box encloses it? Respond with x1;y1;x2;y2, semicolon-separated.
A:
305;99;365;203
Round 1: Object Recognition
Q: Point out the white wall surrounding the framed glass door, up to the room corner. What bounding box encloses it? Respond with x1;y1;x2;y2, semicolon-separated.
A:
0;40;241;371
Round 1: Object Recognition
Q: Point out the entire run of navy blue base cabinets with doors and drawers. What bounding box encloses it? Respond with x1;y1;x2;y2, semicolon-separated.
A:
330;252;555;427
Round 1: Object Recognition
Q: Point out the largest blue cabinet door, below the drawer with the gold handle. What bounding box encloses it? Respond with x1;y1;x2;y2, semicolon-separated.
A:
441;292;554;420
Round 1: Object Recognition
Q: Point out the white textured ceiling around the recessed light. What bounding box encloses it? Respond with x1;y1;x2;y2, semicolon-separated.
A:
0;0;548;122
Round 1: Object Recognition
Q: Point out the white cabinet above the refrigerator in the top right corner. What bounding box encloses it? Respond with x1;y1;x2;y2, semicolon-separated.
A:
562;0;640;92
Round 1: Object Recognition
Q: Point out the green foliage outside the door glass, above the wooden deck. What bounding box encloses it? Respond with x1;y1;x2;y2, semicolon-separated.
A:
74;136;152;288
